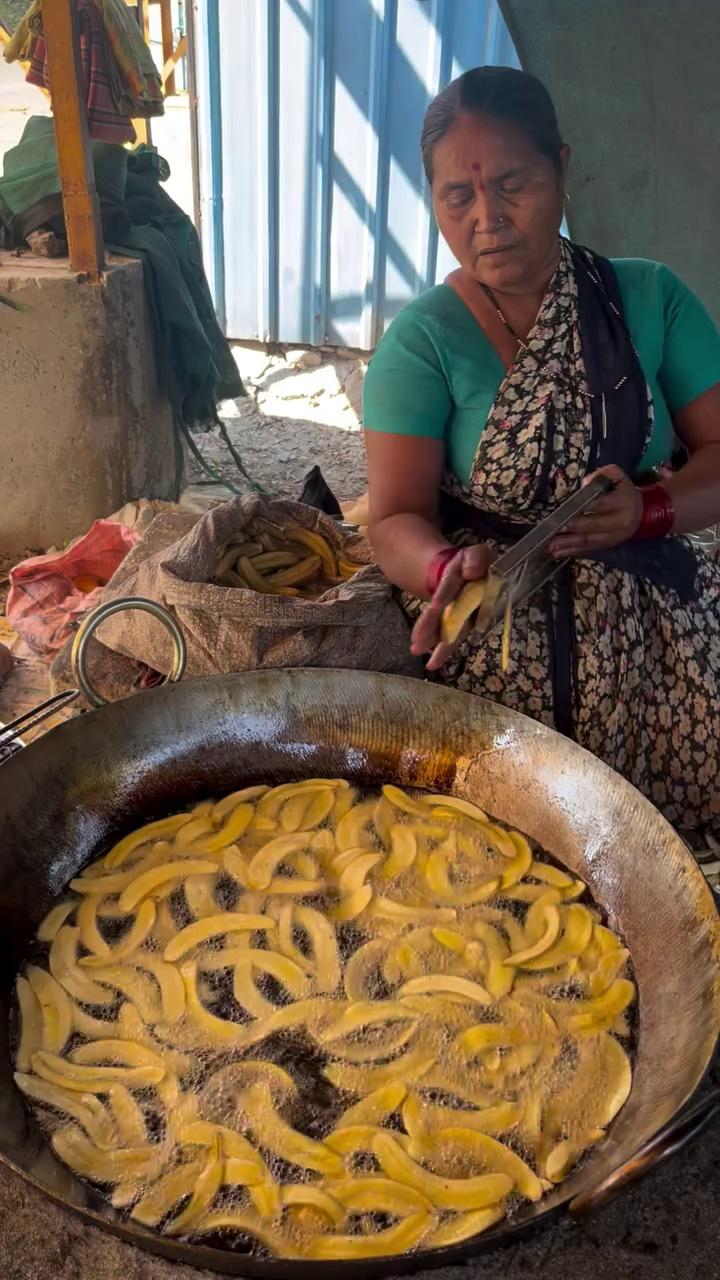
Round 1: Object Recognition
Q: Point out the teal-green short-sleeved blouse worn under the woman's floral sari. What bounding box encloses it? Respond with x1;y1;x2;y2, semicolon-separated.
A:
363;257;720;483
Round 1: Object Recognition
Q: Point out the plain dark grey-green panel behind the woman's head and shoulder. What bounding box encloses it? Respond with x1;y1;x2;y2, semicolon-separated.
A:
501;0;720;323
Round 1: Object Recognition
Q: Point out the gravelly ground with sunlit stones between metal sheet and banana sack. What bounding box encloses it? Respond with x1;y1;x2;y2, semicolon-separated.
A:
188;347;366;499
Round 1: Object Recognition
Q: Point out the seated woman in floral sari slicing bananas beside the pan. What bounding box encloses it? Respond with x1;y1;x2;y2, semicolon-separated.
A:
364;67;720;828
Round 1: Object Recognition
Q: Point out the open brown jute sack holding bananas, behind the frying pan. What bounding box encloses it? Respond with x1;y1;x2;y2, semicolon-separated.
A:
99;497;419;677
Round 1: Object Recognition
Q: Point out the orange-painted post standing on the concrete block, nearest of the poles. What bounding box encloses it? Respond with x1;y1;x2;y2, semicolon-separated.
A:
42;0;105;280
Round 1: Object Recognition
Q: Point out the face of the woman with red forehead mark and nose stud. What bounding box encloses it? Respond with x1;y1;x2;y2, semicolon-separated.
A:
433;114;569;293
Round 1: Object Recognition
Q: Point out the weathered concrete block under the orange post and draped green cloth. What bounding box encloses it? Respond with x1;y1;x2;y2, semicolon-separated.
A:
0;253;176;554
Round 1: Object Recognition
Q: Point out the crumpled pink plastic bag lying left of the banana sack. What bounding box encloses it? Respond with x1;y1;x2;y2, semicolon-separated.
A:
6;520;140;659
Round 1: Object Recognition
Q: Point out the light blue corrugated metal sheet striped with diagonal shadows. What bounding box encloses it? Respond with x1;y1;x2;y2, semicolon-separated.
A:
192;0;519;348
